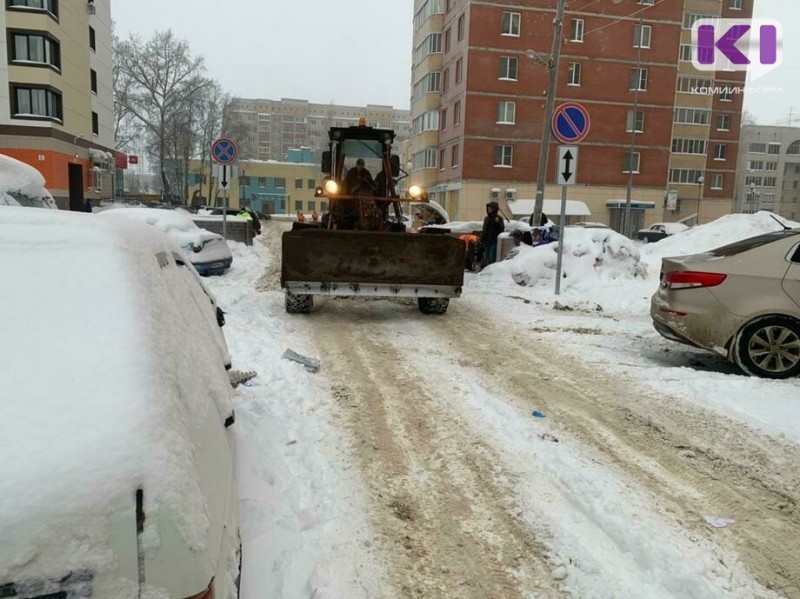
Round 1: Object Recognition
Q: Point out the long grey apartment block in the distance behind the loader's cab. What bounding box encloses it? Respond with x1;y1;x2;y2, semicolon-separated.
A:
231;98;411;160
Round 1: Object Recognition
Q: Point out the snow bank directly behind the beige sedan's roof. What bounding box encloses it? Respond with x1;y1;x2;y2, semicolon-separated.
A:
640;211;800;274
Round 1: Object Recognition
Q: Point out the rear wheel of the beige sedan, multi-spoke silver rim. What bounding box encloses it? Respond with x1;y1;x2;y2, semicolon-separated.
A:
734;316;800;379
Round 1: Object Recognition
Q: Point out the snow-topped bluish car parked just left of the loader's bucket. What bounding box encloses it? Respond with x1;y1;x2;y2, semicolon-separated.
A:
100;208;233;276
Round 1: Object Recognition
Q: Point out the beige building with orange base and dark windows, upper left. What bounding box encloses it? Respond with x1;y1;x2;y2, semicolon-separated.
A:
0;0;117;210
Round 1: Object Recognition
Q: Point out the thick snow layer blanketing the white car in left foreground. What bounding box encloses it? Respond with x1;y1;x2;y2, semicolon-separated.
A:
0;207;231;581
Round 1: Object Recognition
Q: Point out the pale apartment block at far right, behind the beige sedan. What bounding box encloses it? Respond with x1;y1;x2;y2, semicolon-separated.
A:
735;125;800;220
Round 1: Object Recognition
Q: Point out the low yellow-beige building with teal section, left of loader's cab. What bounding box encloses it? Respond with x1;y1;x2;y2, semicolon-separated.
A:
189;160;327;214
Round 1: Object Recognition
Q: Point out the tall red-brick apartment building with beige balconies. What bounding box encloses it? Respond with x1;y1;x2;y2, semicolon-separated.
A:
409;0;752;229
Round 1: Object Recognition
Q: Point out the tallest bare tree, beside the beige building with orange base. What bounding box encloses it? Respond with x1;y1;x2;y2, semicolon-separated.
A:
115;30;212;199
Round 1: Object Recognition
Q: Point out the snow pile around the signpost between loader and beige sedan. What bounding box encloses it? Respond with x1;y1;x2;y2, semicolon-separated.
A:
471;227;647;290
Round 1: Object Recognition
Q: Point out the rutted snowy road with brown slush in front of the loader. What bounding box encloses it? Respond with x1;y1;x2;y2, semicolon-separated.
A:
212;221;800;599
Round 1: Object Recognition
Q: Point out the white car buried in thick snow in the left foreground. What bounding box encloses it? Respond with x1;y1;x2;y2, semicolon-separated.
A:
0;208;241;599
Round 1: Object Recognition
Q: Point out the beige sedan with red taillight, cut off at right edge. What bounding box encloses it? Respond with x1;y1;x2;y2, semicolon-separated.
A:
650;228;800;378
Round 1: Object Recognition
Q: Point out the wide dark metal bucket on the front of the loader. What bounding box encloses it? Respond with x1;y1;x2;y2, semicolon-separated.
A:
281;228;465;298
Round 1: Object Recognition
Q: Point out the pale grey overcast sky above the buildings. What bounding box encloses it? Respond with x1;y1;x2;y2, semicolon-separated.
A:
111;0;800;125
